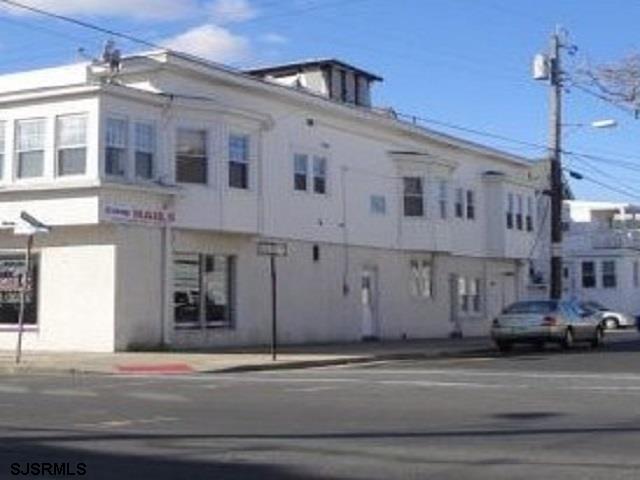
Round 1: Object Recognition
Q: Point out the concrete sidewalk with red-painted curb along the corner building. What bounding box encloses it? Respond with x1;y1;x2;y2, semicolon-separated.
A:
0;337;492;375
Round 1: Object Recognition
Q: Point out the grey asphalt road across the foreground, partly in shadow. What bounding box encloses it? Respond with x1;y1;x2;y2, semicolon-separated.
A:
0;339;640;480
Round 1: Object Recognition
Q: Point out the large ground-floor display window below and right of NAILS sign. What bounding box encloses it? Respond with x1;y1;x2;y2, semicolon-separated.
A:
173;253;235;328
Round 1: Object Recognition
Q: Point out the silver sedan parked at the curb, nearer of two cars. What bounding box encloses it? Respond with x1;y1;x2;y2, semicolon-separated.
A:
491;300;604;352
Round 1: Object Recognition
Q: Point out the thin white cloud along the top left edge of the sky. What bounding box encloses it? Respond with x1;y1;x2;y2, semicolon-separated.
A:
3;0;199;20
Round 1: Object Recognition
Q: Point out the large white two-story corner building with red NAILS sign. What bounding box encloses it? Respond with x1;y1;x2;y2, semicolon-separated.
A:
0;52;538;351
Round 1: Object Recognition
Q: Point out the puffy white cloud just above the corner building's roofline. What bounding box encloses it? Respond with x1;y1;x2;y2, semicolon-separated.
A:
160;24;251;63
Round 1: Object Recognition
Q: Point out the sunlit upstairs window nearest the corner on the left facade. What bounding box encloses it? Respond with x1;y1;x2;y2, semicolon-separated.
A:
56;114;87;176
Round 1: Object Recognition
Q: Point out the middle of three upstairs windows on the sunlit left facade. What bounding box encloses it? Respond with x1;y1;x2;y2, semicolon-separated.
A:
16;118;46;178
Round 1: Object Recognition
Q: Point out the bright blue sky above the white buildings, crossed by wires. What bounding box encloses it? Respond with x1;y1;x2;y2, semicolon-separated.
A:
0;0;640;202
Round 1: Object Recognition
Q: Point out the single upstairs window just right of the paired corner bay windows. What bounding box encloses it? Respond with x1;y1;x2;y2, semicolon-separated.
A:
176;128;208;184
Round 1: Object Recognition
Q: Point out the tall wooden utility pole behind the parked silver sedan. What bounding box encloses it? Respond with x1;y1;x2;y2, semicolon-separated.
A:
549;30;564;300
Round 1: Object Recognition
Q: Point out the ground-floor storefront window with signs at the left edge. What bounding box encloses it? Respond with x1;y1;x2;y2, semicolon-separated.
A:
0;255;39;325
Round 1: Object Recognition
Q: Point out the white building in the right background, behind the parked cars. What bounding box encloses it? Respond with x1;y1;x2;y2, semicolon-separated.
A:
563;200;640;315
